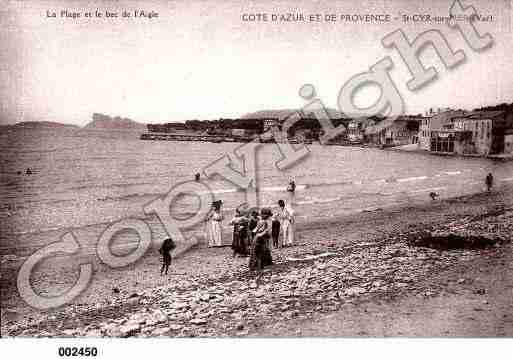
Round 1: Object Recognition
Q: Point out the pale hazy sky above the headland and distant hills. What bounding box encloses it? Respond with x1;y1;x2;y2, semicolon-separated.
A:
0;0;513;126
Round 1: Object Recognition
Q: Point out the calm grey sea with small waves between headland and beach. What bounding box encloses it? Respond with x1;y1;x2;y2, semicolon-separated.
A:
0;128;513;252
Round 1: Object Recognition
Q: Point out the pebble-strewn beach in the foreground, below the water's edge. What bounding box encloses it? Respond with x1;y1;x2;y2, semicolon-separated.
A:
2;185;513;337
